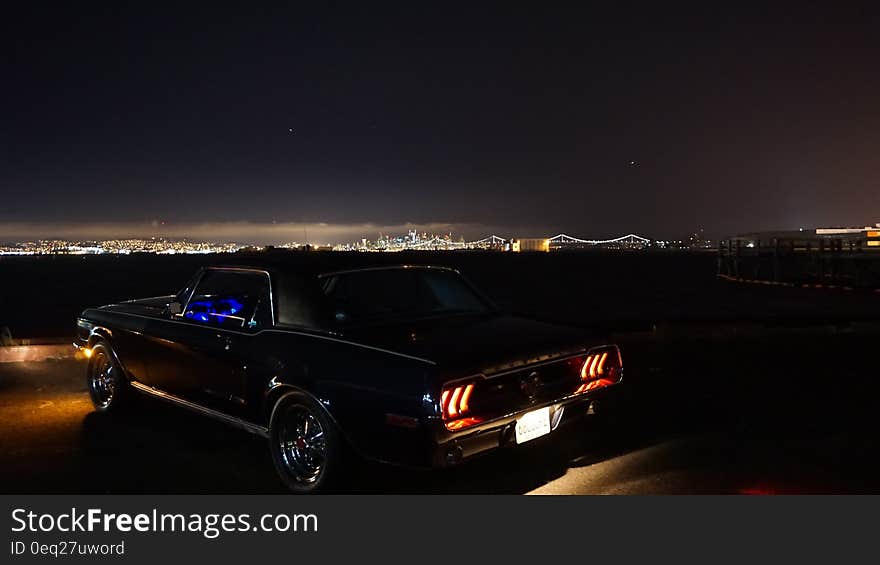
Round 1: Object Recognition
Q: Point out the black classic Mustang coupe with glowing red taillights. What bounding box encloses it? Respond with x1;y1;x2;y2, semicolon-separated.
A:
76;264;623;492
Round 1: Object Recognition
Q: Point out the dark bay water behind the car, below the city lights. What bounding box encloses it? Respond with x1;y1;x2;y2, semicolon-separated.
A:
0;252;880;337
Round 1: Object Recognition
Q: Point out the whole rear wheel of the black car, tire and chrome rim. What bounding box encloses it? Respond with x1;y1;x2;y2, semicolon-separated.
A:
269;392;343;494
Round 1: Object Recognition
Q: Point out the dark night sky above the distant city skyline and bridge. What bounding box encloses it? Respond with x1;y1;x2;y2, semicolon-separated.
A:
0;2;880;241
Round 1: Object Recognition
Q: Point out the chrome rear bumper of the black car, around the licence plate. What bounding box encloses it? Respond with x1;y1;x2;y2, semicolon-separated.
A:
431;384;619;467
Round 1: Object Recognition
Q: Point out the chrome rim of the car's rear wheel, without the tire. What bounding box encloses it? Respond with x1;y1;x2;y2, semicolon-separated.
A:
277;404;327;484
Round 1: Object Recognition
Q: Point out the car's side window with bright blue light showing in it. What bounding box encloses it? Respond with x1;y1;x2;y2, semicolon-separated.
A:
183;269;272;329
